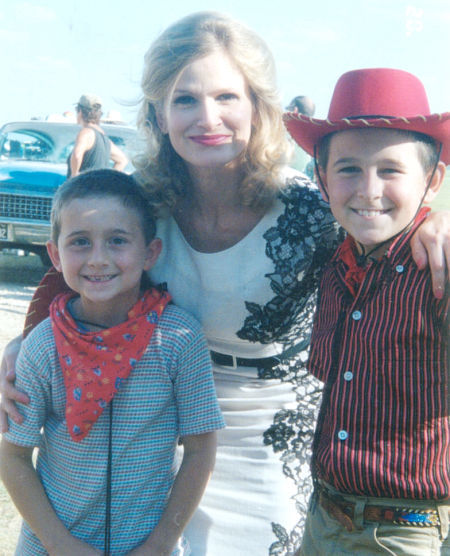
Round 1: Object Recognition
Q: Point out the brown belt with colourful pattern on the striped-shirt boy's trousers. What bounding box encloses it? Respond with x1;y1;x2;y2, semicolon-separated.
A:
319;487;441;532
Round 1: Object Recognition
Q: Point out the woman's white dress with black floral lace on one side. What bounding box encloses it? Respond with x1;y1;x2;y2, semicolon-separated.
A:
150;177;337;556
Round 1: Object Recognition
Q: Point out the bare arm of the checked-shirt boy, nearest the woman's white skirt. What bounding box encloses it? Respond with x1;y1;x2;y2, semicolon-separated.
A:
129;432;217;556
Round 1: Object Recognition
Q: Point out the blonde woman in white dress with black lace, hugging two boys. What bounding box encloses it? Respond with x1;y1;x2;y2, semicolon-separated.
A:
0;12;449;556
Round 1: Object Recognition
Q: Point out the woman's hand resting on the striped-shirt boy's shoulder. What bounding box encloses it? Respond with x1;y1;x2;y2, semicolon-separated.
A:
411;210;450;299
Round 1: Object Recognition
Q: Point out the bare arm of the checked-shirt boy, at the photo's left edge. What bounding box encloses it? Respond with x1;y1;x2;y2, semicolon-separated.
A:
0;438;102;556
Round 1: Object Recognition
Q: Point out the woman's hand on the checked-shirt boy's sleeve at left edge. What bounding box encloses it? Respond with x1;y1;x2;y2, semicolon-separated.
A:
0;336;30;433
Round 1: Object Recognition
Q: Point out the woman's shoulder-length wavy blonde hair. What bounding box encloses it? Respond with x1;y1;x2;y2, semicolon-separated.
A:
135;12;291;211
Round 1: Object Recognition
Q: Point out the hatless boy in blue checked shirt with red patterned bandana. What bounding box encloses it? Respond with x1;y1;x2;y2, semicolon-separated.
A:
0;170;224;556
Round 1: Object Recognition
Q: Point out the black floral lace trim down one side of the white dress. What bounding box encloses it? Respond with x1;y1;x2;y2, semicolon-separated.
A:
237;177;342;556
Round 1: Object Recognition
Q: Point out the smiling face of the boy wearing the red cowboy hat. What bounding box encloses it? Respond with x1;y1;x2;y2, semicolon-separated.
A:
322;129;442;256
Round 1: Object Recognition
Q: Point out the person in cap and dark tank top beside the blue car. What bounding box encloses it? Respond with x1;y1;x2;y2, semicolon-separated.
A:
67;94;128;177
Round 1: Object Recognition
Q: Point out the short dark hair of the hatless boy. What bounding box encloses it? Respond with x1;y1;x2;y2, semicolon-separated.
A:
51;169;156;244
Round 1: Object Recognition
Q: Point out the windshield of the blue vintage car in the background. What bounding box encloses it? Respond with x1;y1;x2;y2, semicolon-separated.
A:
0;130;54;160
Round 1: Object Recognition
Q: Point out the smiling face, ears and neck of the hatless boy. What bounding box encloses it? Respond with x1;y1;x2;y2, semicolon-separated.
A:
49;197;160;327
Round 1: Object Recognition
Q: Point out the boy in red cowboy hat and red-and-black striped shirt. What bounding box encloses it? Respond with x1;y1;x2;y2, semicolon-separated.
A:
285;68;450;556
